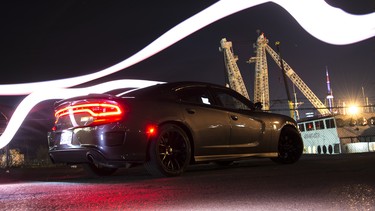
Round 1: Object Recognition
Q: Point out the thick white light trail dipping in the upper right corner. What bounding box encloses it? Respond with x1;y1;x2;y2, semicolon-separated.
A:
274;0;375;45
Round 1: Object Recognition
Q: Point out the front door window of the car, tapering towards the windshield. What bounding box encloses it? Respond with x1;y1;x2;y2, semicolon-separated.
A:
215;90;252;110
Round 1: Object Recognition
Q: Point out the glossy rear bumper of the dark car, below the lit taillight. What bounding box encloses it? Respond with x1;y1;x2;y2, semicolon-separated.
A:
48;125;148;167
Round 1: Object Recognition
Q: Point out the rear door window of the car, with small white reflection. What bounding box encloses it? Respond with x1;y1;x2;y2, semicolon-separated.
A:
177;87;212;105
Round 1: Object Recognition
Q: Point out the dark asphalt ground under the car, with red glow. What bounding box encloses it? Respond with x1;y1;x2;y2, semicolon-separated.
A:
0;153;375;210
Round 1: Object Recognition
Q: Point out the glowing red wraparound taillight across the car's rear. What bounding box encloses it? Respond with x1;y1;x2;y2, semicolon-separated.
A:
55;100;124;127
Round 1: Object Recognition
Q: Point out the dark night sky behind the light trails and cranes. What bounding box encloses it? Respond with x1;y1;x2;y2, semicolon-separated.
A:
0;0;375;115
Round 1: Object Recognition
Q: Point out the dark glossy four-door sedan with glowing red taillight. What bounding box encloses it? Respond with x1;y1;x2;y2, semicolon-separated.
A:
48;82;303;177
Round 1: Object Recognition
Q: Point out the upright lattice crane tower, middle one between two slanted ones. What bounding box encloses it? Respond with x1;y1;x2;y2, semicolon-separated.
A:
248;34;270;110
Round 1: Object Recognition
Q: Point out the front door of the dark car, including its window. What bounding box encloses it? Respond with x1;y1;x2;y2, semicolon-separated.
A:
214;89;266;154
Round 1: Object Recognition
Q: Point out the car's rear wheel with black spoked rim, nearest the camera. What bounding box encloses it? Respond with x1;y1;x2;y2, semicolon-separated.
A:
145;124;191;177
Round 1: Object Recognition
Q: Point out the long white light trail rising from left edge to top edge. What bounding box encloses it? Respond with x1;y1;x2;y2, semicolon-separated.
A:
0;0;267;95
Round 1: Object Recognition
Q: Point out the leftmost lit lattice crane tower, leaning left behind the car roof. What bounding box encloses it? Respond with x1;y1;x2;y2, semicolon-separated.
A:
219;38;250;99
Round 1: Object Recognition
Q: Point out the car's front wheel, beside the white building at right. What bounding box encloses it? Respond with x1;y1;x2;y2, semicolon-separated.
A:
272;127;303;164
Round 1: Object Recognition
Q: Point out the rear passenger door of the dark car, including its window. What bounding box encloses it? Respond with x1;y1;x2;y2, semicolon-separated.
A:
176;86;230;160
